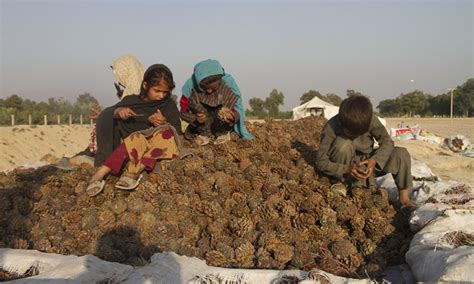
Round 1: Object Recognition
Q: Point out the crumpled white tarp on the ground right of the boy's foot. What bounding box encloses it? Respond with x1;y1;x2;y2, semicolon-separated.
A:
377;161;474;282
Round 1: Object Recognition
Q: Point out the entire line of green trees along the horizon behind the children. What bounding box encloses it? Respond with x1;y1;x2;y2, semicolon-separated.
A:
0;78;474;125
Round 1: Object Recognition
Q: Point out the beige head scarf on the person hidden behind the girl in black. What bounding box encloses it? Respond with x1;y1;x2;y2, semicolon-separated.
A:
112;54;145;98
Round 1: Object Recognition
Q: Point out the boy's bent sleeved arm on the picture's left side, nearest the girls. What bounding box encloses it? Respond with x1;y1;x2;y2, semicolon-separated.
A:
316;123;347;179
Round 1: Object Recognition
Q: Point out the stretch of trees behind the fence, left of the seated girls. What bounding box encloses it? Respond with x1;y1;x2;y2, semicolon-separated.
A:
0;93;98;125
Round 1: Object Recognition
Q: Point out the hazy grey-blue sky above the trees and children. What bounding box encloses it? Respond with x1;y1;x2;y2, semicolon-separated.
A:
0;0;474;109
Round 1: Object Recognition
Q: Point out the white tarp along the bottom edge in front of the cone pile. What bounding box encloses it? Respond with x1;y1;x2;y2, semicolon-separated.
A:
0;249;373;284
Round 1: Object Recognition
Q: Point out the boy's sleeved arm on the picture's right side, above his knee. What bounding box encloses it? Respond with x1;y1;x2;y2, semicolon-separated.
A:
370;115;394;169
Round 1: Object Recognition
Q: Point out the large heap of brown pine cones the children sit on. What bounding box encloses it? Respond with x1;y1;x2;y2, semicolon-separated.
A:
0;117;411;278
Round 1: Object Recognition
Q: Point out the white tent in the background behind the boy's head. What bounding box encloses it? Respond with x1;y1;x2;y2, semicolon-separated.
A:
293;97;387;127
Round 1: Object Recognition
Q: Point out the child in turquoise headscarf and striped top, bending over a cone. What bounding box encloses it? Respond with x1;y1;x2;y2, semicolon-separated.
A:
180;59;253;145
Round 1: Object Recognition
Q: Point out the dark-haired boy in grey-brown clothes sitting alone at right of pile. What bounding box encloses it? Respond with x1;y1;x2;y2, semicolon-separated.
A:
316;96;416;207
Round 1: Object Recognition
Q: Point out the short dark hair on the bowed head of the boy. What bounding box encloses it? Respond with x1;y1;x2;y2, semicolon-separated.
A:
339;95;373;138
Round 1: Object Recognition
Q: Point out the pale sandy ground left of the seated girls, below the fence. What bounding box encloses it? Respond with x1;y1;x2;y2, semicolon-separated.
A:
0;125;92;171
